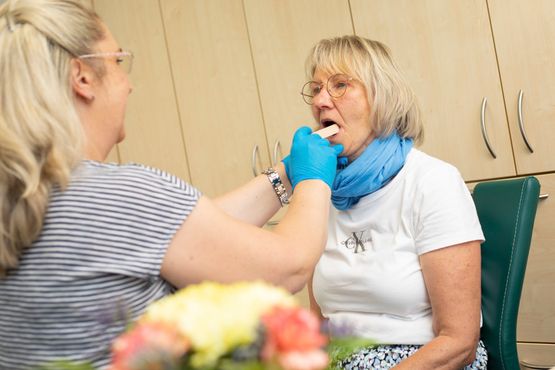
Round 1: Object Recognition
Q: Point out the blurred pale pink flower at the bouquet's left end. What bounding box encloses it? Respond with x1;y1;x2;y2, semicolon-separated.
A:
110;323;189;370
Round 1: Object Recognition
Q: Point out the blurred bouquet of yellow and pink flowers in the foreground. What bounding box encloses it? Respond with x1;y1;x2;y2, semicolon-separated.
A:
110;282;329;370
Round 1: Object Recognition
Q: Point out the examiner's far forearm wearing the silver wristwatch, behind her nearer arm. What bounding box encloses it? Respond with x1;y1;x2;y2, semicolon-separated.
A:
214;163;291;226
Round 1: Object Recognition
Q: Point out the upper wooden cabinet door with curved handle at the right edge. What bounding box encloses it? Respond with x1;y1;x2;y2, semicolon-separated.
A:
488;0;555;174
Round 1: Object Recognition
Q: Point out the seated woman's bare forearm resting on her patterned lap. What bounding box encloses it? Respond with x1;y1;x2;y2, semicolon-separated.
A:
394;335;477;370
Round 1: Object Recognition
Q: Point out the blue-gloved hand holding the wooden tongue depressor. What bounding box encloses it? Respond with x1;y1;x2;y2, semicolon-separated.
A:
283;126;343;190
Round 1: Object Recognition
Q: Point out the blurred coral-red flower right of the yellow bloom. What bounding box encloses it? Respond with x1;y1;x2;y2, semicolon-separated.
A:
262;307;327;359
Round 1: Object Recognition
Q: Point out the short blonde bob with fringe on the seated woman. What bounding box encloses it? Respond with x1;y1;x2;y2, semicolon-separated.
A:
306;35;423;143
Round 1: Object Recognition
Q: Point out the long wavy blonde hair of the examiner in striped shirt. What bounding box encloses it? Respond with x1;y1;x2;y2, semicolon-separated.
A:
0;0;104;276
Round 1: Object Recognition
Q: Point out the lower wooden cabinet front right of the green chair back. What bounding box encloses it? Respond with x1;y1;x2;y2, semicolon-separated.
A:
517;174;555;344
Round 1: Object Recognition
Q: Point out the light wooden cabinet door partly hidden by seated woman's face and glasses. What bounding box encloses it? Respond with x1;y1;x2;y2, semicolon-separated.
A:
244;0;353;162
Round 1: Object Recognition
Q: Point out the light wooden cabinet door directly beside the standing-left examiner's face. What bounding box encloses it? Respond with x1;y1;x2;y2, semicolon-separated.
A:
94;0;189;181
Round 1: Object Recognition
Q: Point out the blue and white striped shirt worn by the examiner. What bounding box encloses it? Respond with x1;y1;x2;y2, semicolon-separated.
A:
0;161;200;370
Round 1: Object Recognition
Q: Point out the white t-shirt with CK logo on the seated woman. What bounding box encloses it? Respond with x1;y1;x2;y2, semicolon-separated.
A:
313;149;484;344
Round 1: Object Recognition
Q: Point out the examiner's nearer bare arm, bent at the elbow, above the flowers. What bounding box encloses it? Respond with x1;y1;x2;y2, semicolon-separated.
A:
165;180;330;292
